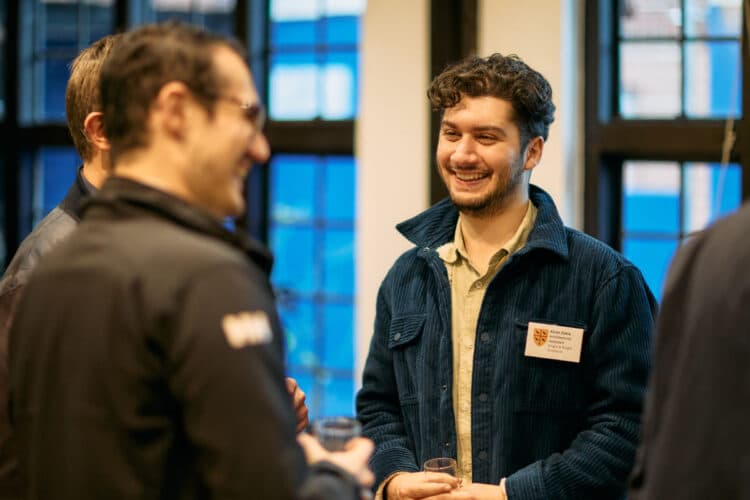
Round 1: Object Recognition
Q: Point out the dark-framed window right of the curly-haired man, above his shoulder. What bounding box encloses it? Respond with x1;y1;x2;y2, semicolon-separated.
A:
585;0;750;297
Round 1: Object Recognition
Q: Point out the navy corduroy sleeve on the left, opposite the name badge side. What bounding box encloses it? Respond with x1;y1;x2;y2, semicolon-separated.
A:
357;278;419;485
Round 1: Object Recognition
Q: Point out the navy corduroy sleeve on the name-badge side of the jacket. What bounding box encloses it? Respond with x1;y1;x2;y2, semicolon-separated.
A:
505;265;656;500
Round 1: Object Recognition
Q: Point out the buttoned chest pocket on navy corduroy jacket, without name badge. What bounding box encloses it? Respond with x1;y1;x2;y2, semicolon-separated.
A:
388;314;425;403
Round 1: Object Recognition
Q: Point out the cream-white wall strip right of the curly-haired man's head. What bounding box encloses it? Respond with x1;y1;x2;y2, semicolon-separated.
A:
478;0;584;227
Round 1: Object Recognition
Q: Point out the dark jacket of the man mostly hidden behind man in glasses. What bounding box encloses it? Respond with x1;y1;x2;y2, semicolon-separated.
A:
0;168;90;500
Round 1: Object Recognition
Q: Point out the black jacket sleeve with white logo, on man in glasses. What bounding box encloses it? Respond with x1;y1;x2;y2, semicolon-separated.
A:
165;266;358;499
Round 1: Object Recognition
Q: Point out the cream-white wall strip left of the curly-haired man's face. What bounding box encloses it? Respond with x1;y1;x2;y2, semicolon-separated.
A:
355;0;430;386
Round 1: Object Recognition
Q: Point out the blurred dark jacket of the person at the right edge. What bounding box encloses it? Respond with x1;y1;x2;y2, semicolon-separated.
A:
628;200;750;500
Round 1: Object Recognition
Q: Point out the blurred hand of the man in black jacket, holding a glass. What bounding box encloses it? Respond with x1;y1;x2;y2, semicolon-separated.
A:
297;432;375;488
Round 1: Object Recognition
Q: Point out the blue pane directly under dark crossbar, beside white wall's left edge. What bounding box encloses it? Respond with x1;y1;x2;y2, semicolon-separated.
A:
323;156;357;222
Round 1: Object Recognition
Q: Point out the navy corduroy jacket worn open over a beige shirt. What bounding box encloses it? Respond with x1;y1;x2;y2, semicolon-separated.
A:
357;186;656;500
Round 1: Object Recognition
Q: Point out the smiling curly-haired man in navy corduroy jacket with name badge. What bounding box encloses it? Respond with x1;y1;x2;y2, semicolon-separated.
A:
357;54;656;500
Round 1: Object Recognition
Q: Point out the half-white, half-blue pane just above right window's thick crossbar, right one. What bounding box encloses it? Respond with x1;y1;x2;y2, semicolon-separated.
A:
685;42;742;118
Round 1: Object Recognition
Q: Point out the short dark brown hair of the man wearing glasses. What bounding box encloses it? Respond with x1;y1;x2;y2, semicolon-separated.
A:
100;21;245;163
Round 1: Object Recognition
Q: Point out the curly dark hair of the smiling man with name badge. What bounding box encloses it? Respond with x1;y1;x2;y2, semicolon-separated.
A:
427;54;555;149
